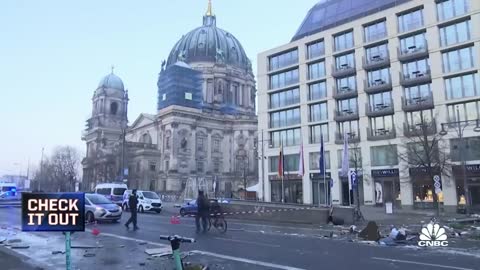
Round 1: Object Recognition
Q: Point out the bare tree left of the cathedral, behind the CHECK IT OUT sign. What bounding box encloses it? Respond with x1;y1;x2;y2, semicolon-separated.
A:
35;146;80;192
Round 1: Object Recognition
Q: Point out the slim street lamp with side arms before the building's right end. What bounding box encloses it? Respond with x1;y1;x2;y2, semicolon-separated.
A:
438;106;480;215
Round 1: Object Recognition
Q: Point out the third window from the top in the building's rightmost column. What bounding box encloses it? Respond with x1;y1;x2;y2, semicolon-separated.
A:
442;47;476;73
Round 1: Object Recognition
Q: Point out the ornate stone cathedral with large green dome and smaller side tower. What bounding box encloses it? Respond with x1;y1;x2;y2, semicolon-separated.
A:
82;1;258;197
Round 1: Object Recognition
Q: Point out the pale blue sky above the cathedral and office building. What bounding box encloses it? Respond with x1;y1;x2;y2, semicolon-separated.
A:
0;0;317;176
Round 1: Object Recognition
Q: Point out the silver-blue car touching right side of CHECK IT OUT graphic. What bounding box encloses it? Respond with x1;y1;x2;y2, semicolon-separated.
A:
85;193;122;222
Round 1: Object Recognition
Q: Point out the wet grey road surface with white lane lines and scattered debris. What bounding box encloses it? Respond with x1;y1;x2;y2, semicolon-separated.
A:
0;208;480;270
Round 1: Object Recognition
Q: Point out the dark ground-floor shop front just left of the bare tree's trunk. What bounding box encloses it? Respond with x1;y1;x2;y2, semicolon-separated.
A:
371;169;402;208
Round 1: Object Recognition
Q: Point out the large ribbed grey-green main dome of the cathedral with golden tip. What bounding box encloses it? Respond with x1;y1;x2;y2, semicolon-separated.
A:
167;1;251;72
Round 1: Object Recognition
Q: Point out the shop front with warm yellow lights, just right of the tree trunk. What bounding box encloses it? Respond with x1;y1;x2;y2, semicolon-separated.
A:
409;168;443;209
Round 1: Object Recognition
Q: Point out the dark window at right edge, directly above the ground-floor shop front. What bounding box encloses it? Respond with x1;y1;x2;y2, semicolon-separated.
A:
450;137;480;161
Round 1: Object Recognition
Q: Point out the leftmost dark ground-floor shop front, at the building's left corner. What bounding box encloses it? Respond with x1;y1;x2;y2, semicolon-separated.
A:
269;174;303;204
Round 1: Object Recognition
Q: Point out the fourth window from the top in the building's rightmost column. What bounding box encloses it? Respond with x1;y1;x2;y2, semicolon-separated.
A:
445;73;480;99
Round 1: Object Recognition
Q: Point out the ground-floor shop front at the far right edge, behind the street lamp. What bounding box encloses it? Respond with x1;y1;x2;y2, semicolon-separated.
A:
453;164;480;210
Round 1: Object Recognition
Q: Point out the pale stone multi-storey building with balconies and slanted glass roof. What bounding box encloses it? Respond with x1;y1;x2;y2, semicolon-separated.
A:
257;0;480;211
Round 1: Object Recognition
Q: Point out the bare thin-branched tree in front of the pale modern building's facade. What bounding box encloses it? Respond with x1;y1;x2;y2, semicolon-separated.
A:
398;111;450;216
